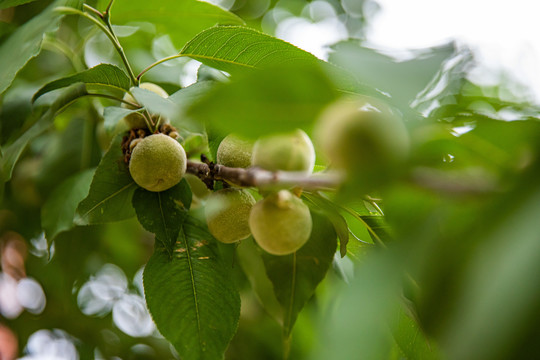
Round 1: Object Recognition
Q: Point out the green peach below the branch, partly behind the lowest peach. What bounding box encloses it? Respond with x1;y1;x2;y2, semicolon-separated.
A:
204;188;255;244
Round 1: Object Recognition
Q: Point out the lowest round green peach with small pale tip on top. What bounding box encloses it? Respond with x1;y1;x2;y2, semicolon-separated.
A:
249;190;313;255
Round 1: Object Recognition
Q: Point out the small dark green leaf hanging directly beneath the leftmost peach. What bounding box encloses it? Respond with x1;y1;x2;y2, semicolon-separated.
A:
133;179;191;253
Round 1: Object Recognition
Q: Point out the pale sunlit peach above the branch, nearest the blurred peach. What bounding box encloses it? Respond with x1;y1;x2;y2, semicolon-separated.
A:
252;129;315;174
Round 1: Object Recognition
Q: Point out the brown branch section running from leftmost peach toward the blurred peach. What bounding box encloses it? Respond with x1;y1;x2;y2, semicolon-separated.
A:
187;160;344;190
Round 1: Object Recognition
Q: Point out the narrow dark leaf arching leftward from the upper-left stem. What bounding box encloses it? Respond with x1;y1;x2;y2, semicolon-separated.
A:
32;64;131;102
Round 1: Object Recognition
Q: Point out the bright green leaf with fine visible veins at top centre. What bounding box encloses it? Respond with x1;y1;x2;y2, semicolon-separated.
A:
180;26;319;74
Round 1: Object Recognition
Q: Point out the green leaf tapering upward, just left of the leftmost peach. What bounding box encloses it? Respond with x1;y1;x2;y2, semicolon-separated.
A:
75;135;136;225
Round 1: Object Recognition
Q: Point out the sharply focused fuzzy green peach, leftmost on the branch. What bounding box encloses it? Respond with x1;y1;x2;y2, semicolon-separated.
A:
129;134;187;192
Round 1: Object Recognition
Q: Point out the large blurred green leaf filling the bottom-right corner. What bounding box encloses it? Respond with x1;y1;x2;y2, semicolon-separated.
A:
439;186;540;360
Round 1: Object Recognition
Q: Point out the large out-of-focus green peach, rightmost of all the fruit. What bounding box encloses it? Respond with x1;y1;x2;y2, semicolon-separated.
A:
315;97;410;185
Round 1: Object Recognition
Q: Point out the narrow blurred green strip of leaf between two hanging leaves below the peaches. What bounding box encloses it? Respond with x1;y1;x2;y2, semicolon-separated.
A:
236;238;283;325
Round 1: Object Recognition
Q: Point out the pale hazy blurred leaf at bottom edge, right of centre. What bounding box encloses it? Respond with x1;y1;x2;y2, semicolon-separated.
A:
311;251;403;360
